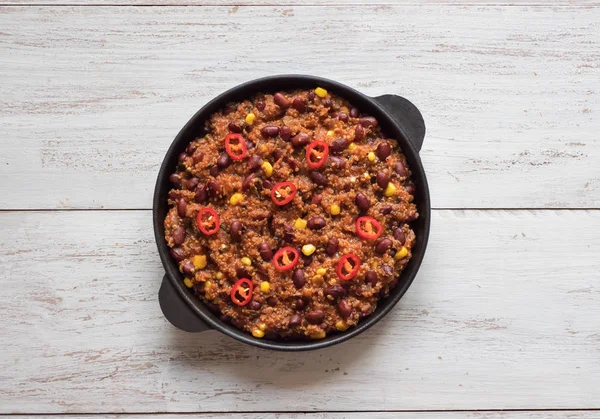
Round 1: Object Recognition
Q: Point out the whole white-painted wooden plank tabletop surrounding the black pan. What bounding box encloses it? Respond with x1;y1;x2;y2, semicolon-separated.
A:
0;0;600;419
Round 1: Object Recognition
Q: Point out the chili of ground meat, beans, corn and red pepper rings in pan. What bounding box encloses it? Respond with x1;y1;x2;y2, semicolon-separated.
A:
165;87;418;340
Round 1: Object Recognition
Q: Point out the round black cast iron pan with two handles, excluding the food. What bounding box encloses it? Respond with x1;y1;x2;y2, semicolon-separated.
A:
152;75;431;351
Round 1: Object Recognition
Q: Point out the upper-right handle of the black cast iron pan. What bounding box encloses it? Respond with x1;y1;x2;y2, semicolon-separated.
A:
373;95;425;151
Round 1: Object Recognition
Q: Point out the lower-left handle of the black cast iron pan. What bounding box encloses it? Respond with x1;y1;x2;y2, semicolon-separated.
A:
158;275;210;332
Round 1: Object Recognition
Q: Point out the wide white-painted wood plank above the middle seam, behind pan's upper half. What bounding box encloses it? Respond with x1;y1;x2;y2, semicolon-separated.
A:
0;5;600;209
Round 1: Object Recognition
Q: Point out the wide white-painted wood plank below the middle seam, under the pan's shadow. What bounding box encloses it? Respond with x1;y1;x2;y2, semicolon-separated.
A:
0;211;600;417
